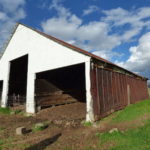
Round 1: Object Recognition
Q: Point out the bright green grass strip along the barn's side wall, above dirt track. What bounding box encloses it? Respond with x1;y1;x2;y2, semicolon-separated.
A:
112;100;150;123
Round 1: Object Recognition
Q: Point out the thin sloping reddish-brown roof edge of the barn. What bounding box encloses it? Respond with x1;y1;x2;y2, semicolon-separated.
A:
0;23;147;80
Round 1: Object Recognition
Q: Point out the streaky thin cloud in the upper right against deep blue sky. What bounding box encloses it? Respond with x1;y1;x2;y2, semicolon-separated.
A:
102;7;150;42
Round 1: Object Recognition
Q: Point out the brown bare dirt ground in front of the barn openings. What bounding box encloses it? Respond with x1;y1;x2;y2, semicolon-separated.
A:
0;103;149;150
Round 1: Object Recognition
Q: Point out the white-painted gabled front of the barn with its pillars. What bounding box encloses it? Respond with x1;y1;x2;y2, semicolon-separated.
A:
0;24;93;120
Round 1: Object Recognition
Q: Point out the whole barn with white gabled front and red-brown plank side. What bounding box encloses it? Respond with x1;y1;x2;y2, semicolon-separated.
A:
0;23;148;121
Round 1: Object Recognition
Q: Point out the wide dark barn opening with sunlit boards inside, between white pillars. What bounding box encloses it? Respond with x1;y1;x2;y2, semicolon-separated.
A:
35;63;86;108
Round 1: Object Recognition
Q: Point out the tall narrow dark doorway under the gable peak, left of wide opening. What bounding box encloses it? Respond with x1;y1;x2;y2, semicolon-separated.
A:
8;55;28;106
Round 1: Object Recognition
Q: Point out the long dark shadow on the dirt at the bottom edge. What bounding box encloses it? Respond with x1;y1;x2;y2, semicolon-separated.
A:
25;133;61;150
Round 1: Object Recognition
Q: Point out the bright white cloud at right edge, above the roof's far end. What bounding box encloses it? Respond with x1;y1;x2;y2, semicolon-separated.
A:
116;32;150;76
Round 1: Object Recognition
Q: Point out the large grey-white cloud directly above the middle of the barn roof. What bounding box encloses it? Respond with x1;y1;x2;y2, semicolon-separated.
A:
41;0;120;59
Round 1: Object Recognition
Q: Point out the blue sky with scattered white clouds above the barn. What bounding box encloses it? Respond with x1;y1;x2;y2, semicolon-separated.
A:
0;0;150;78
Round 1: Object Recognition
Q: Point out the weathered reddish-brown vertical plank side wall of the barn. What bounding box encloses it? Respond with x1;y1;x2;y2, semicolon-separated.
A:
91;68;149;120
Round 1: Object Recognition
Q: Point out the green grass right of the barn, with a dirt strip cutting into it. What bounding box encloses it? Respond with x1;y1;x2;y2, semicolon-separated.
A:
96;100;150;150
